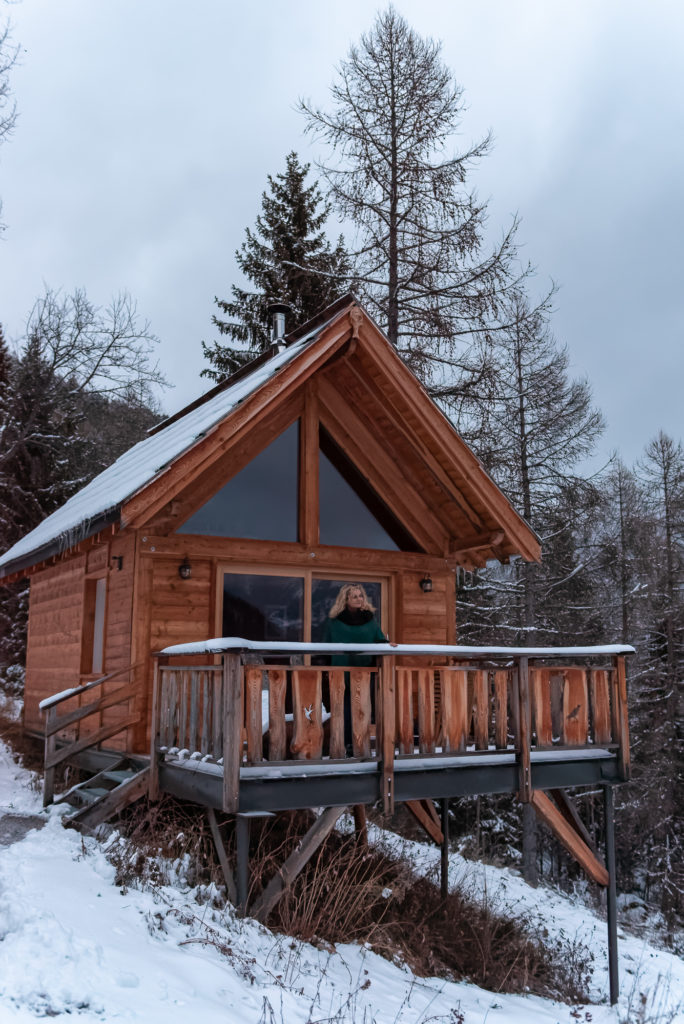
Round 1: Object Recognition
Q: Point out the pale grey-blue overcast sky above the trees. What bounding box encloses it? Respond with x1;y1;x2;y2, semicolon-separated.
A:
0;0;684;461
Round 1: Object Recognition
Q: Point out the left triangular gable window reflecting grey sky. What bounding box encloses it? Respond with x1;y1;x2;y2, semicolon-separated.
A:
178;421;299;541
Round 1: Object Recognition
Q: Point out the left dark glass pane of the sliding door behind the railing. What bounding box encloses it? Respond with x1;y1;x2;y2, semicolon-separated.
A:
222;572;304;641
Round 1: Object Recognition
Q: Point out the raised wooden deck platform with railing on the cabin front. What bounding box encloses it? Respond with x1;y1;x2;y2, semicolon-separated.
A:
152;645;629;813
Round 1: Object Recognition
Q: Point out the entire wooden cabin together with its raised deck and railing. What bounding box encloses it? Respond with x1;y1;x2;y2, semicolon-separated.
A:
0;296;629;999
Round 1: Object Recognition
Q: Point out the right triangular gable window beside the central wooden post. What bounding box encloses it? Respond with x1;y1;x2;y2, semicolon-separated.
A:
318;427;422;551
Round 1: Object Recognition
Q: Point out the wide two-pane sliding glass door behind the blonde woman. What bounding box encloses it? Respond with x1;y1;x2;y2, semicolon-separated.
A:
221;570;388;643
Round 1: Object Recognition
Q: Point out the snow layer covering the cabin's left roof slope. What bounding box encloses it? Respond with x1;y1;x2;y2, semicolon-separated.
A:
0;317;325;577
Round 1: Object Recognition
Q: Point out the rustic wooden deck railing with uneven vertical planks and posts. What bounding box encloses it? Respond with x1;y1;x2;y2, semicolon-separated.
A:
153;641;631;810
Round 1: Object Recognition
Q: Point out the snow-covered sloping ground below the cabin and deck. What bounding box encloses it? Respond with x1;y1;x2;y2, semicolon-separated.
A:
0;743;684;1024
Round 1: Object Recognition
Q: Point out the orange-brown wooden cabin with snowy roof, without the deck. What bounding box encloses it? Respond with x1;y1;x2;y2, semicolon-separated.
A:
0;297;540;753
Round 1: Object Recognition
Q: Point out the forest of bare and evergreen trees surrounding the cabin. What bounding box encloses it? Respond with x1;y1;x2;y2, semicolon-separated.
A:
0;2;684;935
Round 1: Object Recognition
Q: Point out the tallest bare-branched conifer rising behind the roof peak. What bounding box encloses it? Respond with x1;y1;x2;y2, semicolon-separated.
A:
300;6;526;376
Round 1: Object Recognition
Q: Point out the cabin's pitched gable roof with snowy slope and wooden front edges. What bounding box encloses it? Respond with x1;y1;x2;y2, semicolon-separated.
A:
0;295;539;579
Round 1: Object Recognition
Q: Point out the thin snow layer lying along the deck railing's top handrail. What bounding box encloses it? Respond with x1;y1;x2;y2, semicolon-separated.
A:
161;637;635;658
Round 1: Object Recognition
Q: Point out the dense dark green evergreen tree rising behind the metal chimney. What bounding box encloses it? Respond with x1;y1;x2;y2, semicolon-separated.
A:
202;153;351;380
